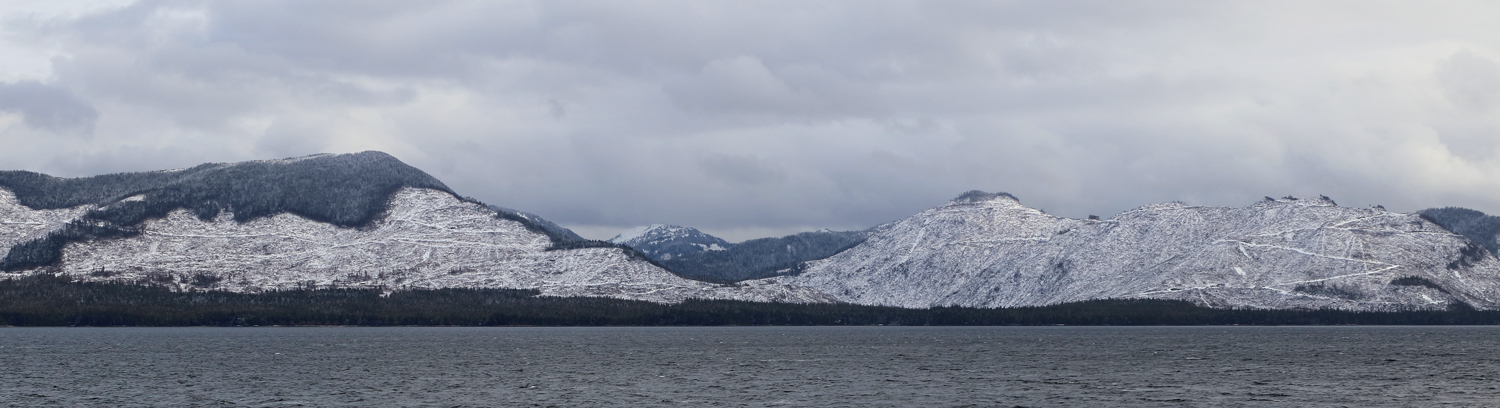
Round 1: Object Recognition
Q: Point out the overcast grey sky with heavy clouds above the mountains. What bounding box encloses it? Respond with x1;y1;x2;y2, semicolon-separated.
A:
0;0;1500;242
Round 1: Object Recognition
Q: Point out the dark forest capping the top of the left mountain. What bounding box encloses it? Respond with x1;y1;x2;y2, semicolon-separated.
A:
0;152;452;272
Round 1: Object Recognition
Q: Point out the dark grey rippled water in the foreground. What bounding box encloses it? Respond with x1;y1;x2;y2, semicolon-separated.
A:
0;327;1500;407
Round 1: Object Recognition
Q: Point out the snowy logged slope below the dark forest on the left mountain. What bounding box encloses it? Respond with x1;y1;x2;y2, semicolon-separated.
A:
11;188;828;303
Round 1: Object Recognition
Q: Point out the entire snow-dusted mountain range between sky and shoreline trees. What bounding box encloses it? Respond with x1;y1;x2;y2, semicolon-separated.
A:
0;152;1500;311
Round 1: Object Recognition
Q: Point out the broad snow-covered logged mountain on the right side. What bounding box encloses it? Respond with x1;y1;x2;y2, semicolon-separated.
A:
767;192;1500;311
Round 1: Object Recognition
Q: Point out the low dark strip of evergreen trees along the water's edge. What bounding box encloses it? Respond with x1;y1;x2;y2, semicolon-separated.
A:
0;275;1500;326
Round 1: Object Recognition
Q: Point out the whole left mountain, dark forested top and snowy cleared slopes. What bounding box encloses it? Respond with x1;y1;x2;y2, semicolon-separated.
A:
0;152;831;303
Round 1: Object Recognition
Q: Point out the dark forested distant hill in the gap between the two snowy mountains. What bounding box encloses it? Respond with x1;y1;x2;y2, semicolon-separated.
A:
662;230;870;282
